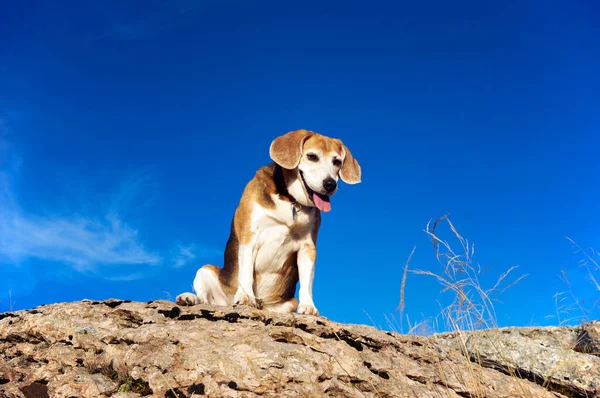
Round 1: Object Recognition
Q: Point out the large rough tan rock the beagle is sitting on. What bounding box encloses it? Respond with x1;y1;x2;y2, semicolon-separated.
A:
0;300;600;398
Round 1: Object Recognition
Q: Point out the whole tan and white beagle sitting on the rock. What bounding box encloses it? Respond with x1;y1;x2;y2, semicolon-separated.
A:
176;129;361;315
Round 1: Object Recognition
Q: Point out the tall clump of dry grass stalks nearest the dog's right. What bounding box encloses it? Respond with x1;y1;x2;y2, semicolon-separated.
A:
388;216;531;397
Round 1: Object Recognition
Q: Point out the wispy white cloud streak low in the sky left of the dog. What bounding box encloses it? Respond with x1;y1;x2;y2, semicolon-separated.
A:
0;126;218;281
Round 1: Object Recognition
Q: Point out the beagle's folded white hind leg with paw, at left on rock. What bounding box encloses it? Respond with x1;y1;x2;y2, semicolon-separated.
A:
175;264;229;305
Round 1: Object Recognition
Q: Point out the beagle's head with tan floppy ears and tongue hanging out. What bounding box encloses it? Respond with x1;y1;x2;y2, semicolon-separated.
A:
269;129;361;212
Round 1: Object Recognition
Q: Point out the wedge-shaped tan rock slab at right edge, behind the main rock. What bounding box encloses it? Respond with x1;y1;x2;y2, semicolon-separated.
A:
435;322;600;398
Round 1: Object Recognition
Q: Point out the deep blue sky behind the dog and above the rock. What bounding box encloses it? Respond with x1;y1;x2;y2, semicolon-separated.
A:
0;1;600;328
